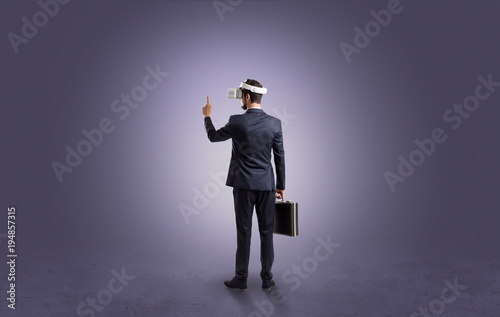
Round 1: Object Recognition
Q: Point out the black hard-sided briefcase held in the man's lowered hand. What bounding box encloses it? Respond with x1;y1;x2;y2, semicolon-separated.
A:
274;200;299;237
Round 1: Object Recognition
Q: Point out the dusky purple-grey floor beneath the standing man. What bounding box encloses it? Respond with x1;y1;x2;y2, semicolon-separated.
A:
1;236;500;317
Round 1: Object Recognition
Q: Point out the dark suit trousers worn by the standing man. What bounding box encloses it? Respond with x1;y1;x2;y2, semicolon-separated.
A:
233;188;276;282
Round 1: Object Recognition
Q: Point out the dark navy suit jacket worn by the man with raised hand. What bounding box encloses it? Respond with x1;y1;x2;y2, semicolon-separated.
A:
205;109;285;190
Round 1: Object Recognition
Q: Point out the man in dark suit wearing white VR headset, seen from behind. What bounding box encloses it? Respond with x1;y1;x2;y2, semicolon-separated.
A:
202;79;285;291
